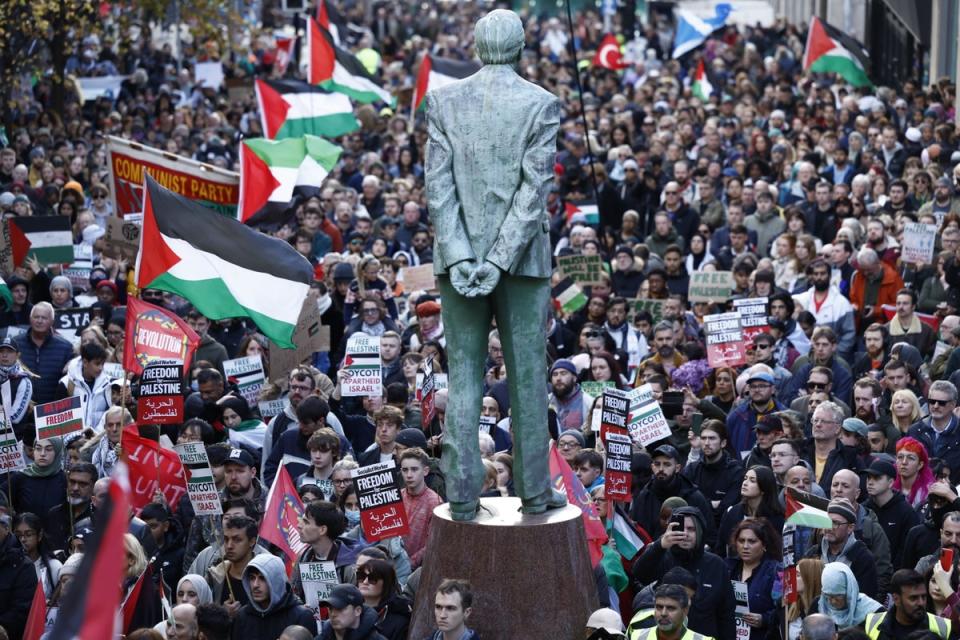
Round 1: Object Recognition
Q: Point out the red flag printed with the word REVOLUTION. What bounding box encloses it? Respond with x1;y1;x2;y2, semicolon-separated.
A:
123;298;200;375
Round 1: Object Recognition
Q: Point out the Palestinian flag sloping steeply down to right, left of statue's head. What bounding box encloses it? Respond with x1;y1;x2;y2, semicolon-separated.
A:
307;18;396;106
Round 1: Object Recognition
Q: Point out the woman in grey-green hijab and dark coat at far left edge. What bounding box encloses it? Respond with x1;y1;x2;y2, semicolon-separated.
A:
0;438;67;513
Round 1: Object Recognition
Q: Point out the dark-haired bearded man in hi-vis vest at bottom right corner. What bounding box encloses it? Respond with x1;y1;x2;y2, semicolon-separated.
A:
863;569;951;640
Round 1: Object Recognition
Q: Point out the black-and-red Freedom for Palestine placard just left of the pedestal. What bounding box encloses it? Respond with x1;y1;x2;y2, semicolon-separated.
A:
350;460;410;542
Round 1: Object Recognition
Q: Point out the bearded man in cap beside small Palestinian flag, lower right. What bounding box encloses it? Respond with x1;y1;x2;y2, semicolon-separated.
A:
807;498;880;600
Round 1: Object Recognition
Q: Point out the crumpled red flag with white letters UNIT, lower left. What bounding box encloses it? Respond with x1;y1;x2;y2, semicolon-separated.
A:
120;424;187;513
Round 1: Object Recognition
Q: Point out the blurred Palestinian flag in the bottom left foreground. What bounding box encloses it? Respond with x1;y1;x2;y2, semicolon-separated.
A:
48;462;133;640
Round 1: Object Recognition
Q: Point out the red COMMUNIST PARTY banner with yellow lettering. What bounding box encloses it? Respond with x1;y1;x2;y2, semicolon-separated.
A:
107;136;240;218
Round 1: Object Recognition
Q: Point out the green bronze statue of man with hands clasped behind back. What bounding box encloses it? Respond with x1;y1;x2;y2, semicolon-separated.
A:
426;9;566;520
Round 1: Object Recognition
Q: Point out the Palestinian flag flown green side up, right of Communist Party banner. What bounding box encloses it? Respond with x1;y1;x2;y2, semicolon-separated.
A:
237;135;342;224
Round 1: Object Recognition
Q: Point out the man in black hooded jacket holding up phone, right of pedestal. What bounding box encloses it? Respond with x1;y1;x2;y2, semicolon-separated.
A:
633;507;736;638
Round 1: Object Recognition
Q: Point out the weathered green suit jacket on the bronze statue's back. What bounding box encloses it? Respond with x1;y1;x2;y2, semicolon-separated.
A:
425;65;560;278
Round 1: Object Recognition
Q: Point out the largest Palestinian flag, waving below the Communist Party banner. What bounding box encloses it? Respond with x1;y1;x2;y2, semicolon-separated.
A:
136;175;313;349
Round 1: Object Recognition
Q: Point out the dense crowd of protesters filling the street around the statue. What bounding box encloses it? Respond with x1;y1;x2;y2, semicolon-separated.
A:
0;2;960;640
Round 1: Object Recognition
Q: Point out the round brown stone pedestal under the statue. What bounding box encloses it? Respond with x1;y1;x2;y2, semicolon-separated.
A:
409;498;599;640
